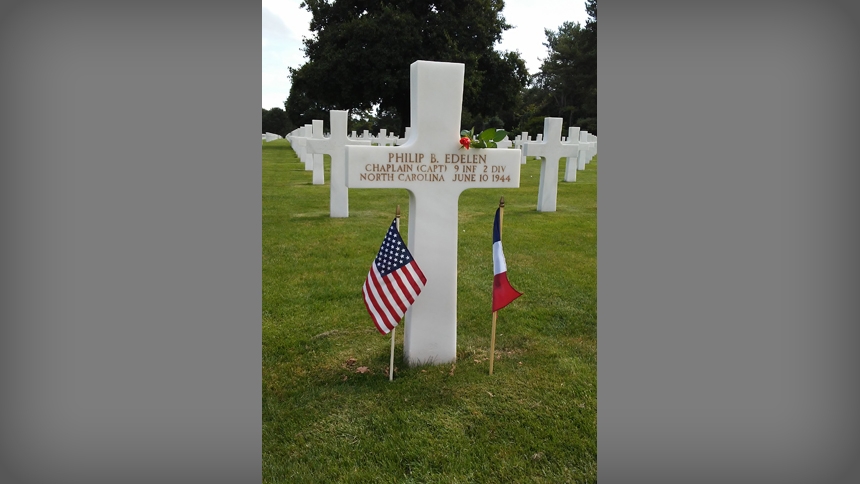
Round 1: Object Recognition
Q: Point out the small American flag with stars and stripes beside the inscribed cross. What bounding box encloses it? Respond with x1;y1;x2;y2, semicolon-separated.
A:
362;218;427;334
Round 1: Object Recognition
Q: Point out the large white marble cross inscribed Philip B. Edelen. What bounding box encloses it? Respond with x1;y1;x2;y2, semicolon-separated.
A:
346;61;520;365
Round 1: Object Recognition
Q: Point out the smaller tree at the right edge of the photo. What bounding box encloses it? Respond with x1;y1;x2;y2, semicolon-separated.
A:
534;0;597;134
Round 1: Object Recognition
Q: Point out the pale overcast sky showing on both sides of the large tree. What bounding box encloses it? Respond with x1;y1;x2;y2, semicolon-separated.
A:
262;0;588;109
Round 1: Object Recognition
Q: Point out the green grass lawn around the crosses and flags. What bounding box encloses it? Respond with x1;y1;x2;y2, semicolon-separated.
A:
262;140;597;483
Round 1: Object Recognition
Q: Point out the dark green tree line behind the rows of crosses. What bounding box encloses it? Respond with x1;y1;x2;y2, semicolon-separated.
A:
263;0;597;140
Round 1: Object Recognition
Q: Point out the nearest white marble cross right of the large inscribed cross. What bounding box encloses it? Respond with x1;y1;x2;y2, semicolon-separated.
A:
525;118;578;212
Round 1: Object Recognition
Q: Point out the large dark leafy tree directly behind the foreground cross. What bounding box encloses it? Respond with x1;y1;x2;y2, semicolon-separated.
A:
286;0;528;132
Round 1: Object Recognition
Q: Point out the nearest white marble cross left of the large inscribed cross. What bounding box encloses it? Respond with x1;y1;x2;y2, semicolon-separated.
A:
308;111;370;218
